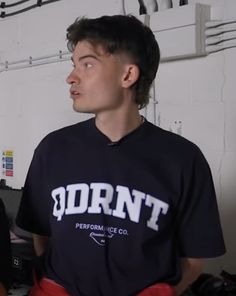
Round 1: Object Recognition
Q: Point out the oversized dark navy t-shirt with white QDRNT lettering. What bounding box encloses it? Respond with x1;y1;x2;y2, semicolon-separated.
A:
17;119;225;296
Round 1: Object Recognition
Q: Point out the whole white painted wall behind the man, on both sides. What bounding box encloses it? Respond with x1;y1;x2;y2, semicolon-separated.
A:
0;0;236;273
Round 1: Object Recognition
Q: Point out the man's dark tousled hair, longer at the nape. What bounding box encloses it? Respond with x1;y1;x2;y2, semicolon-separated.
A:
67;15;160;109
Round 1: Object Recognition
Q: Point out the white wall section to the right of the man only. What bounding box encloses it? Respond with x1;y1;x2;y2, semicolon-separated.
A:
156;0;236;273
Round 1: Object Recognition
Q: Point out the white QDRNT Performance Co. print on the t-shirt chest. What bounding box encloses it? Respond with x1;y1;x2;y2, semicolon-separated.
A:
51;183;169;245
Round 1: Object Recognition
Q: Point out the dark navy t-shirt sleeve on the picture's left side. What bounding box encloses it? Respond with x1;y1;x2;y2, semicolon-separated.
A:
16;147;50;236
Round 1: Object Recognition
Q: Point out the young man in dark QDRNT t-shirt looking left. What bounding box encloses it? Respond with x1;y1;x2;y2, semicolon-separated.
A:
17;16;225;296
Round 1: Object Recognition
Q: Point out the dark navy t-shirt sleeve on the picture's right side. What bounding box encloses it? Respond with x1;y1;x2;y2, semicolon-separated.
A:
176;148;225;258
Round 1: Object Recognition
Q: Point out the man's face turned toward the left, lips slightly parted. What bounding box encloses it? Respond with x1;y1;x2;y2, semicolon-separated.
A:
67;41;127;114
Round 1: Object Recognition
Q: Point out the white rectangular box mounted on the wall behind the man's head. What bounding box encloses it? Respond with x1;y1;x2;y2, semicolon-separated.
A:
150;3;211;62
